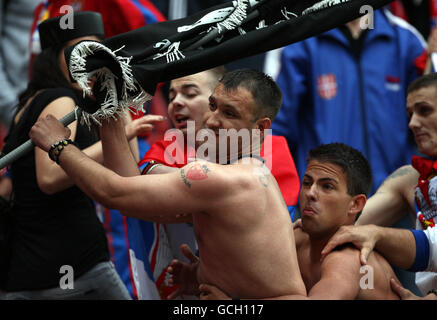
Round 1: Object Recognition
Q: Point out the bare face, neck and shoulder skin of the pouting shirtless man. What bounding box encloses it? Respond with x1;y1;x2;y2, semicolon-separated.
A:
191;160;397;300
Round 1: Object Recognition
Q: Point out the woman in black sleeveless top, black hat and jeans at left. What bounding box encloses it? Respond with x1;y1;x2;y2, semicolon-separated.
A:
0;12;146;299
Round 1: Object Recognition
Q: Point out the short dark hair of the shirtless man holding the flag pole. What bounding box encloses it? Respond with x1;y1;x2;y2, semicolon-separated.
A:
220;69;282;121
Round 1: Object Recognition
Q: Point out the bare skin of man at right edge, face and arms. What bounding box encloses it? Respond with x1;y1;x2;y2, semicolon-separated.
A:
323;86;437;298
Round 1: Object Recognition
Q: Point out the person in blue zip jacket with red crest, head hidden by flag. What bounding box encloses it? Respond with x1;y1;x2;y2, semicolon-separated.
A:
272;10;426;193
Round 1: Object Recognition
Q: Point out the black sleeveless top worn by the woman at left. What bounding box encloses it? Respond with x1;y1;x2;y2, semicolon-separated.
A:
4;88;109;291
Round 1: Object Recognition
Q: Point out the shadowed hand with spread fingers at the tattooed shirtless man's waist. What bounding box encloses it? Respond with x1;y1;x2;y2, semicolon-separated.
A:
167;244;199;300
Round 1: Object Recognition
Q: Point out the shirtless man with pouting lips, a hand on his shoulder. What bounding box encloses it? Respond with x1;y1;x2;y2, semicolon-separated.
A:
173;144;397;300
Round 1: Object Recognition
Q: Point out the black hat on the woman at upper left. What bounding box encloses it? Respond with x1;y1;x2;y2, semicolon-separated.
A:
38;11;105;50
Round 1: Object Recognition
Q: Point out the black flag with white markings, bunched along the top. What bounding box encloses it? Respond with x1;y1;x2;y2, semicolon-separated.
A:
65;0;391;106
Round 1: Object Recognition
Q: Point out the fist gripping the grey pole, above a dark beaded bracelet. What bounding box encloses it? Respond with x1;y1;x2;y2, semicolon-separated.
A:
29;114;71;152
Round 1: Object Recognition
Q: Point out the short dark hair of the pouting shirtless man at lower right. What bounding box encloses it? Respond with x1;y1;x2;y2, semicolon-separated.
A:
307;143;372;196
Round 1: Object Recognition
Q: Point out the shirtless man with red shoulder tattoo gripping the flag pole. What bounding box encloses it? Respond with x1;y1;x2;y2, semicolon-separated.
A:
30;70;306;299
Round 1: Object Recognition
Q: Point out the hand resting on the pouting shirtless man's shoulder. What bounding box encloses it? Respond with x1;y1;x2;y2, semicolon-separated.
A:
321;225;377;265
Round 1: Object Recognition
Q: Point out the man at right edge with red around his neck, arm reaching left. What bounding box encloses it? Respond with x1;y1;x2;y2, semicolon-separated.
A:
324;73;437;298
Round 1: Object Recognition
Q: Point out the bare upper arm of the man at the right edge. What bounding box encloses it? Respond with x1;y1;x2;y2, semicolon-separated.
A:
355;166;419;227
